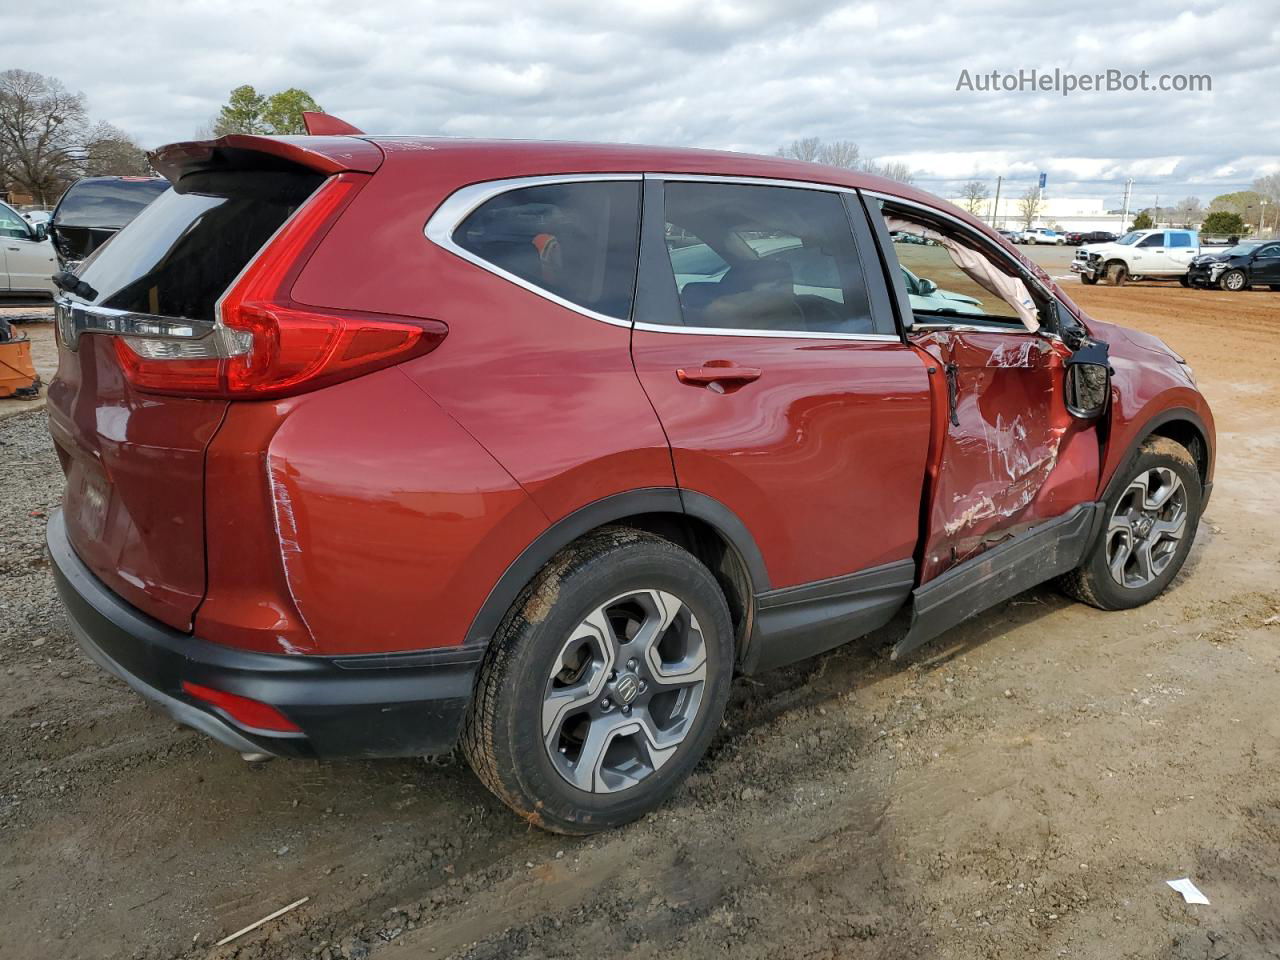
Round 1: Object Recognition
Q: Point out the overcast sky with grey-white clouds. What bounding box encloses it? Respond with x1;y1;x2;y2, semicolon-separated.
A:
0;0;1280;206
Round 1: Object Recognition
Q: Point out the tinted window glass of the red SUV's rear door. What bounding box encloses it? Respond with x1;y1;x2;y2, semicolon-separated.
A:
666;182;892;333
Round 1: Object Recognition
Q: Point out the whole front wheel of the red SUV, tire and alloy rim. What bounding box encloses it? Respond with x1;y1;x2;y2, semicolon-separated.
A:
1060;436;1202;611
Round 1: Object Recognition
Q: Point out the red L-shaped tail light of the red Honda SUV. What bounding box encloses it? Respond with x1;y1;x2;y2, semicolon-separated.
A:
115;173;448;399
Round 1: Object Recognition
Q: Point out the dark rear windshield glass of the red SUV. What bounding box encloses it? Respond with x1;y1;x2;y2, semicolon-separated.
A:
79;172;324;320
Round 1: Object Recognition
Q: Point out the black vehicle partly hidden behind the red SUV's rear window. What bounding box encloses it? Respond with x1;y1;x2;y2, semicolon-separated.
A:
50;177;169;269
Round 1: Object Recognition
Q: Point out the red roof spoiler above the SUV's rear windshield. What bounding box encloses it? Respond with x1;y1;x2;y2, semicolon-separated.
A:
147;134;383;183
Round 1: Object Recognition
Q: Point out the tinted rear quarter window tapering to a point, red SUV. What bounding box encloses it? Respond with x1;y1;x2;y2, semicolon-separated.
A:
453;182;640;319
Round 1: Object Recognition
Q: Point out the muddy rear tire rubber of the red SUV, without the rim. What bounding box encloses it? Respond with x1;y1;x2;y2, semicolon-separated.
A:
462;526;733;836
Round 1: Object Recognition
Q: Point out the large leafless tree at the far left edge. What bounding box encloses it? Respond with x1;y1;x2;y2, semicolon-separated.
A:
0;70;86;204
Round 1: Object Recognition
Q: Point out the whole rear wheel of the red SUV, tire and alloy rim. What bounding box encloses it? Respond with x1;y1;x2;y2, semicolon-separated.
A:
462;527;733;835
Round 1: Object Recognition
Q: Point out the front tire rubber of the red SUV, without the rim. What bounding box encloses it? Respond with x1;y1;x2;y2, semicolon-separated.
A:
1057;436;1203;611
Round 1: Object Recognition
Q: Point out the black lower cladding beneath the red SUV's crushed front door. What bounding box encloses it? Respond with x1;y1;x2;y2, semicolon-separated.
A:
892;503;1106;659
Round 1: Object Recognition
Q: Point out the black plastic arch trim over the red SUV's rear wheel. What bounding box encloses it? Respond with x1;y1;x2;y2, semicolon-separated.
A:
465;486;769;649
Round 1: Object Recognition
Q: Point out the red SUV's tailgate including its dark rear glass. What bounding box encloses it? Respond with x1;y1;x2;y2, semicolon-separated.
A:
49;138;360;631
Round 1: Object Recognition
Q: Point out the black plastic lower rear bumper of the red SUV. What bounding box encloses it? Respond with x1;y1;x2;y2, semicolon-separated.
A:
46;511;484;756
